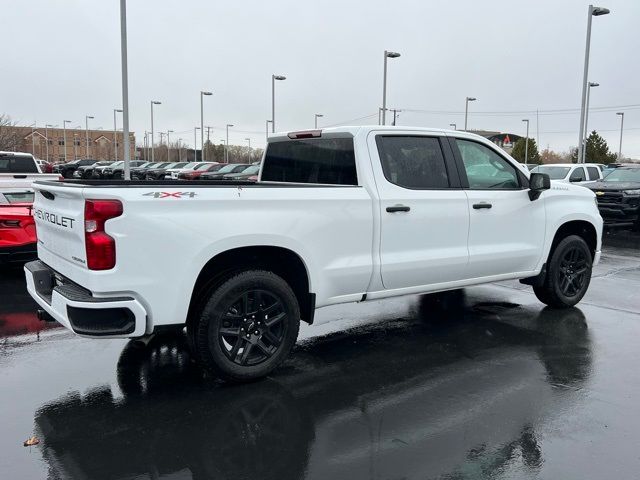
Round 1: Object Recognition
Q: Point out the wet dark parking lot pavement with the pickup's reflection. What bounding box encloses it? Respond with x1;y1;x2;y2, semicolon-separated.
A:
0;247;640;480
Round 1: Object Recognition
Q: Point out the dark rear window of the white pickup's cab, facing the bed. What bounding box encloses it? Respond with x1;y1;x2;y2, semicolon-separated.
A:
261;138;358;185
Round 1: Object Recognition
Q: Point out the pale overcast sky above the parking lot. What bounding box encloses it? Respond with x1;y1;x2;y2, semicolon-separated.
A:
5;0;640;158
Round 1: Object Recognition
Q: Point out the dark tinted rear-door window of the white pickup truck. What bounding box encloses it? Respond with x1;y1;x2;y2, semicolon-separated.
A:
376;135;450;189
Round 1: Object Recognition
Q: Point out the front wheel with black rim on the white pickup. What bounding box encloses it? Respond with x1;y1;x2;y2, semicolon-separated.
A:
533;235;593;308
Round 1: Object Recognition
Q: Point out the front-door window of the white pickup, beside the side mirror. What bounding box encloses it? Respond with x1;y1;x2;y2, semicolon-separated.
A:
456;138;520;190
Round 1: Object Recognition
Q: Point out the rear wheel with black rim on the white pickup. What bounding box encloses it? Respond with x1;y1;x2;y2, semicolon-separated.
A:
188;270;300;382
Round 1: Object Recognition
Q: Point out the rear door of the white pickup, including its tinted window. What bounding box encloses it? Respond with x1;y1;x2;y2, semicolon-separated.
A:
368;132;469;289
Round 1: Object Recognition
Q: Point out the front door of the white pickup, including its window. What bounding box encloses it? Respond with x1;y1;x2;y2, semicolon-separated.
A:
451;138;546;278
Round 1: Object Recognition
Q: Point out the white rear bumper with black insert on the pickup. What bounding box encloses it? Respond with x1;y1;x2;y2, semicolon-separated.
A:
24;260;147;338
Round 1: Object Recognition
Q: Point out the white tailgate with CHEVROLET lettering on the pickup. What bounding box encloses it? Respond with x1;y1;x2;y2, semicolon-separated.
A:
33;183;87;268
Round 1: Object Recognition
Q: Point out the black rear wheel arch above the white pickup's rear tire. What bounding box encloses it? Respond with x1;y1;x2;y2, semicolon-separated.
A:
187;245;315;324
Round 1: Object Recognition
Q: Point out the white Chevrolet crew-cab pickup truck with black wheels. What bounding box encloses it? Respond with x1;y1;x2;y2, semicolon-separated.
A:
25;126;602;381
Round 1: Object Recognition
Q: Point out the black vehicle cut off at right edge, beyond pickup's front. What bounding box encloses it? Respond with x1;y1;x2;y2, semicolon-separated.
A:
589;165;640;231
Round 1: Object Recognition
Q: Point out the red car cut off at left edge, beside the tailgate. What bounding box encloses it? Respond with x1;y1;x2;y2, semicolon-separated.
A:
0;203;37;265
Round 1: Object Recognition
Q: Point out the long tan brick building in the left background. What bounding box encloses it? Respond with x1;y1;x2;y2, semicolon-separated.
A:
4;126;136;163
